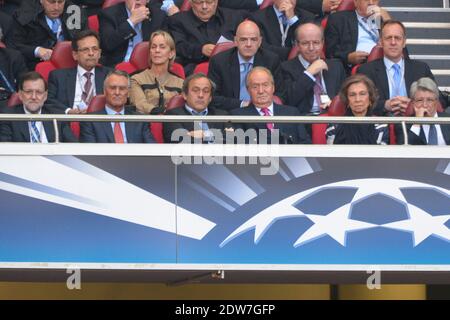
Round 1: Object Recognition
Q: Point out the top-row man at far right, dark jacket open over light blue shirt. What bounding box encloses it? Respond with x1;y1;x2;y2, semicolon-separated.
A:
325;0;390;71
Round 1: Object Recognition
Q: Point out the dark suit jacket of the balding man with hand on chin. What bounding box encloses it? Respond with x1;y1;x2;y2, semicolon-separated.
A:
281;58;346;114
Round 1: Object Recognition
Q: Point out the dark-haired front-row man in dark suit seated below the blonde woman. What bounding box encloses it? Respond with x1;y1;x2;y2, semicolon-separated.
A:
163;73;232;143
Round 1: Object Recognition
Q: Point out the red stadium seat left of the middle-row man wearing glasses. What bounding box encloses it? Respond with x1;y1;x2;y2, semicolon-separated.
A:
35;41;77;81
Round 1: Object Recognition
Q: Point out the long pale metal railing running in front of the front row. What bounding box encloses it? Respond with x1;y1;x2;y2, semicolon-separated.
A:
0;114;450;145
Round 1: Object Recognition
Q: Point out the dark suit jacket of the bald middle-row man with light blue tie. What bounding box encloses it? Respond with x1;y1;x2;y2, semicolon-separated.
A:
208;48;282;110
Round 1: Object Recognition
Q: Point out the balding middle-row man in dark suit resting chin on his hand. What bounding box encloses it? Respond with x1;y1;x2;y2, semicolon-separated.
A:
281;23;346;115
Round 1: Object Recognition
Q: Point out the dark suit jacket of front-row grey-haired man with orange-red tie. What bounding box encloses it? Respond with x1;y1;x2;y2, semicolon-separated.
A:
80;107;155;143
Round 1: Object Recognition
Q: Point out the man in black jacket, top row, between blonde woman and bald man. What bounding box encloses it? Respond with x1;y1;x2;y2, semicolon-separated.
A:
169;0;245;75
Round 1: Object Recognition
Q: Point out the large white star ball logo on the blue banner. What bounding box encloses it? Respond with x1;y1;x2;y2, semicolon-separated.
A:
220;179;450;247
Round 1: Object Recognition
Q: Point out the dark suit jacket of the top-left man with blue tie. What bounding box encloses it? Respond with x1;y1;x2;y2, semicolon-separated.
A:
8;1;87;70
